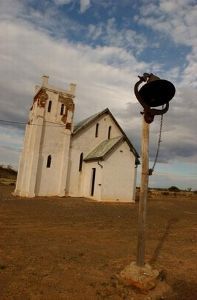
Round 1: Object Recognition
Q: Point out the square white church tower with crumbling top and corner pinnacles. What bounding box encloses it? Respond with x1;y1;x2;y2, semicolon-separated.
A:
14;76;76;197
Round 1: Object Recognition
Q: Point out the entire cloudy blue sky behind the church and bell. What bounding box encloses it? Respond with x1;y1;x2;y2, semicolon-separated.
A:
0;0;197;190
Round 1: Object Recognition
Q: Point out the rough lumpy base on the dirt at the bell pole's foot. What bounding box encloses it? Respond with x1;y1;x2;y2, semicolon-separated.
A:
119;262;171;299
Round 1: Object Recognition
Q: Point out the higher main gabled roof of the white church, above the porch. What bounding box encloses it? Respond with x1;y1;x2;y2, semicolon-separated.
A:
73;108;140;164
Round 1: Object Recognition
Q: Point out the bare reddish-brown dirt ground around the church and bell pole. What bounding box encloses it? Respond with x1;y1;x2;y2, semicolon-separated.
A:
0;185;197;300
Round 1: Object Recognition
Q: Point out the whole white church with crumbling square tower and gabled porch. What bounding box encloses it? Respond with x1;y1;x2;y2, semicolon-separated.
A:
14;76;139;202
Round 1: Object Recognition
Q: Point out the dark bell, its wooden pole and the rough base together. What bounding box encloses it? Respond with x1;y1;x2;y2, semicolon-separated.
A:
120;73;175;299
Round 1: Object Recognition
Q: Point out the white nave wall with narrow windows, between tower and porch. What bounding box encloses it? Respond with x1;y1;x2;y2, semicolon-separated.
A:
67;114;122;196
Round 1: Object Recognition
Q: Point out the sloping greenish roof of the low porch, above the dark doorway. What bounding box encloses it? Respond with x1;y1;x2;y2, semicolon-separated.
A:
84;136;123;161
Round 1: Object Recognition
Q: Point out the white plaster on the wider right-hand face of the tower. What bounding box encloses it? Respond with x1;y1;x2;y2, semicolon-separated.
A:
35;91;72;196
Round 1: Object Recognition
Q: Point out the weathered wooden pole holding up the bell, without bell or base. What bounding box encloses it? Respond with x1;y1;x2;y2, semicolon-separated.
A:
137;115;149;267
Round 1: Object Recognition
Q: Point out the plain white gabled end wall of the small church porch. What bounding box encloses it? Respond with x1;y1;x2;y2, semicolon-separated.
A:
101;142;136;202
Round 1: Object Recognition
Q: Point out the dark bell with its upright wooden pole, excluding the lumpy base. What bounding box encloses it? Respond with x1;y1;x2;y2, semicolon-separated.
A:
134;73;175;267
